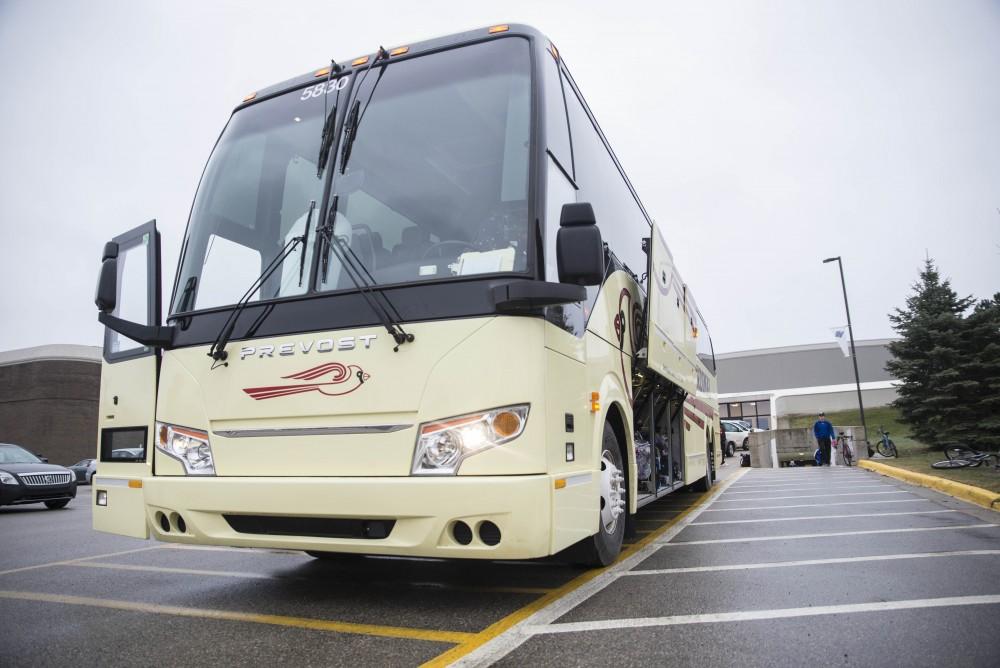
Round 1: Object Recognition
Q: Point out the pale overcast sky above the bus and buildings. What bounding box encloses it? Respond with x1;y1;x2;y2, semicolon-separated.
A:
0;0;1000;352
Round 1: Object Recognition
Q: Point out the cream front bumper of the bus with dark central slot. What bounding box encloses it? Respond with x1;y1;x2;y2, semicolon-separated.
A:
105;474;576;559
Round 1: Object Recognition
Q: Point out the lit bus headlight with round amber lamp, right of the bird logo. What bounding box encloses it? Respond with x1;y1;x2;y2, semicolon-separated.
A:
410;404;528;475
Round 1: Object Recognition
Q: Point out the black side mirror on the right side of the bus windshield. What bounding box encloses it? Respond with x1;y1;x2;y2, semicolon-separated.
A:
556;202;604;285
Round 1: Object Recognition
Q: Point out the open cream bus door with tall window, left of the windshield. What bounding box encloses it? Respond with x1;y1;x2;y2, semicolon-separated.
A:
91;221;160;538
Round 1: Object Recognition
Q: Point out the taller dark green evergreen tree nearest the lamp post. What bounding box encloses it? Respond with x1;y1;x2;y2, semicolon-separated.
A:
886;258;973;447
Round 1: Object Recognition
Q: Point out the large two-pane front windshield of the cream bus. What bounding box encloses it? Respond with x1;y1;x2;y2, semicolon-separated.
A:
172;38;531;313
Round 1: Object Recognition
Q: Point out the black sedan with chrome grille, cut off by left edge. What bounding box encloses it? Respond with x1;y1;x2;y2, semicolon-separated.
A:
0;443;76;509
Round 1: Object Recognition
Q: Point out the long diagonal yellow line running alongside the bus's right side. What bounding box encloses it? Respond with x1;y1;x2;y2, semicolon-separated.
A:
421;469;749;668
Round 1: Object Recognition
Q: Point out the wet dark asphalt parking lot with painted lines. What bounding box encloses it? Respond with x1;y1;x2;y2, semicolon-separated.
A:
0;460;1000;666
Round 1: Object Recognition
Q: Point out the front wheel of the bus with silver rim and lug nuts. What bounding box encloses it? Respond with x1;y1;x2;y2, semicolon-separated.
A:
576;422;628;566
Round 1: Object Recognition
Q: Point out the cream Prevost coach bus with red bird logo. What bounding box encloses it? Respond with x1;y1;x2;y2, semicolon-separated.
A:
93;25;720;564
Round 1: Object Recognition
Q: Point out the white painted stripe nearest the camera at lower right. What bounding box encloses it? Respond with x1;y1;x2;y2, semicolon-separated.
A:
524;595;1000;635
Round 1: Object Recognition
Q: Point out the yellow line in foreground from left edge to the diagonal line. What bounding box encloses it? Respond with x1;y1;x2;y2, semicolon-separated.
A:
0;591;475;644
